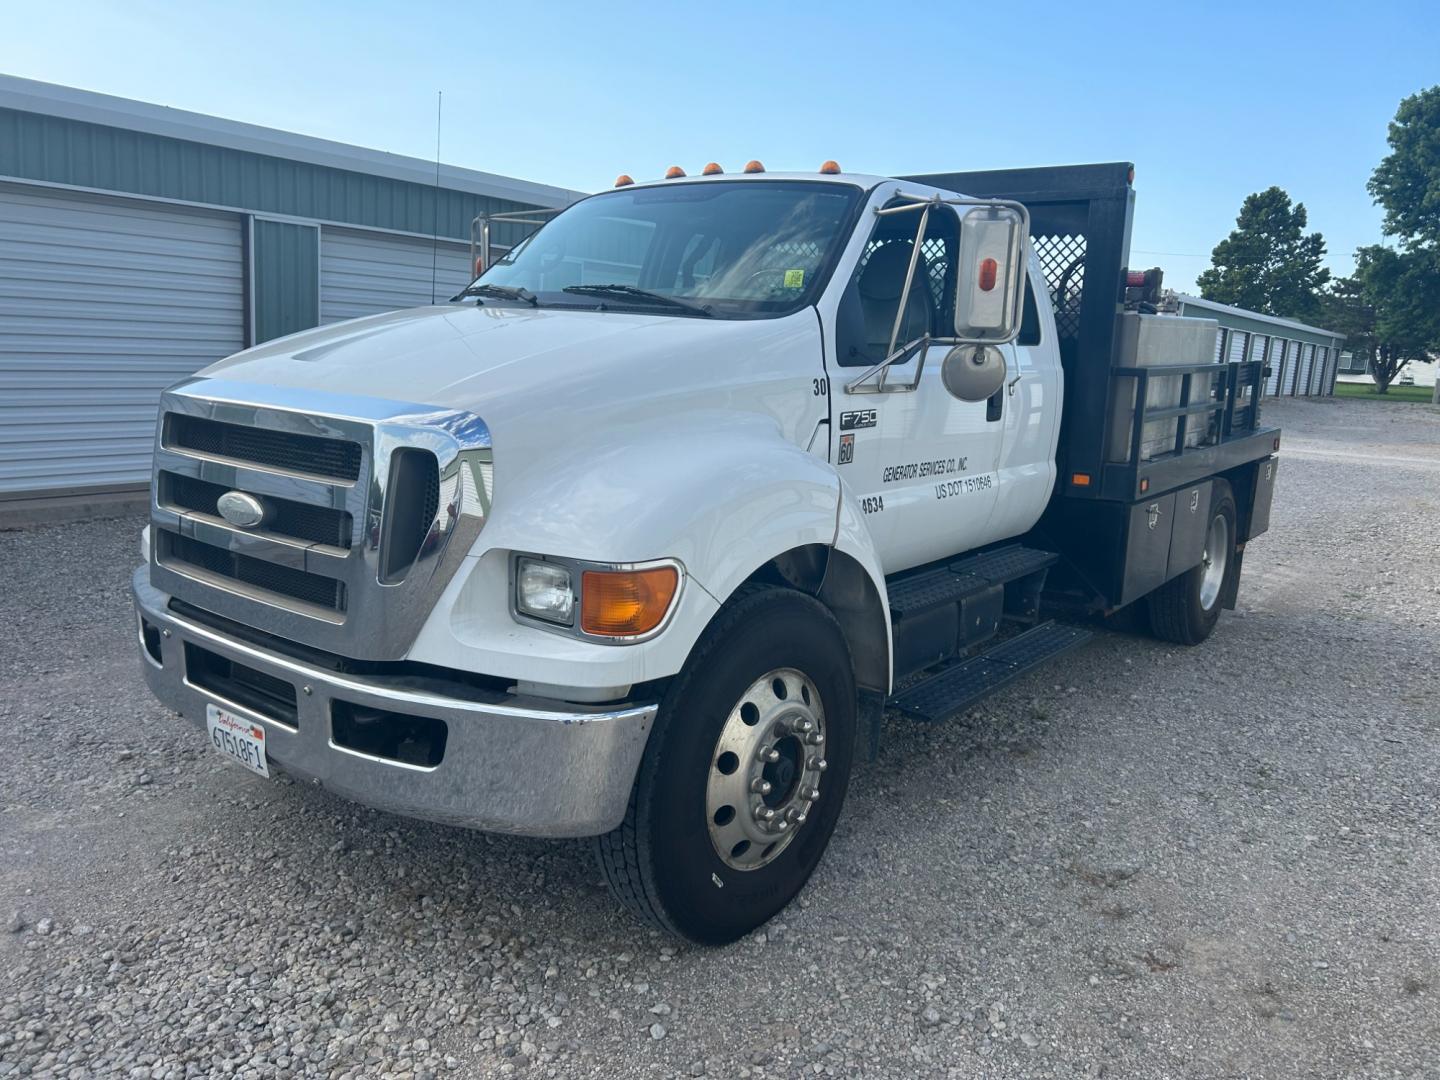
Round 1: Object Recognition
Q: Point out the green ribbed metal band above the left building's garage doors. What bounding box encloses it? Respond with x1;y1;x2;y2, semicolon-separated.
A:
0;108;544;243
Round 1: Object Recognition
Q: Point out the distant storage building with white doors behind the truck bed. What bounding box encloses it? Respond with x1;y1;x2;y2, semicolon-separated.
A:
1175;294;1345;397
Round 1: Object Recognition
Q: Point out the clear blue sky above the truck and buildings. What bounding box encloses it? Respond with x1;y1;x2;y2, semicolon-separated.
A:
0;0;1440;288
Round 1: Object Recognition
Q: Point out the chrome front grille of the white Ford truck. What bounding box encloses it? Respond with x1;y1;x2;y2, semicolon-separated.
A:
150;379;494;660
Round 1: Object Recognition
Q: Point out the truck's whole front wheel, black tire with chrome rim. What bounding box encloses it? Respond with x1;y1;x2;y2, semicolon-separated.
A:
595;588;857;945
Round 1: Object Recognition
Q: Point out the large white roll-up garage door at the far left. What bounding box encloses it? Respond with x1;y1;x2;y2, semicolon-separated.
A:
0;184;245;497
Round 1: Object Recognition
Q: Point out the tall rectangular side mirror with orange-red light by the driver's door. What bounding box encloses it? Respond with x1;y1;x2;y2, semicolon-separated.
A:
955;204;1030;347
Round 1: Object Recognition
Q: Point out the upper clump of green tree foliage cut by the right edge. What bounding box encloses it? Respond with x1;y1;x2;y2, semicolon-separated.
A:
1368;86;1440;249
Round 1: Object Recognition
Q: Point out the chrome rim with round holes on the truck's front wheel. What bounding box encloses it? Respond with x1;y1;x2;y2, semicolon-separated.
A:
706;668;827;870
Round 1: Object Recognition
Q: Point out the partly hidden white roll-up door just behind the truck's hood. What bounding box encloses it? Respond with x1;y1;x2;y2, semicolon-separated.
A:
320;228;472;323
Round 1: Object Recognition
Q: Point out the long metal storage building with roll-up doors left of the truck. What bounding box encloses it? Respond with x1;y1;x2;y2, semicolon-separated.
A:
0;76;579;507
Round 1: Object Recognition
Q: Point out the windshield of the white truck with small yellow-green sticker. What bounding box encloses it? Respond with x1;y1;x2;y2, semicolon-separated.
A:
472;180;860;317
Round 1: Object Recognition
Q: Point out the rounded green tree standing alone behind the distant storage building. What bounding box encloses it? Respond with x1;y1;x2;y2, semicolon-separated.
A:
1197;187;1331;320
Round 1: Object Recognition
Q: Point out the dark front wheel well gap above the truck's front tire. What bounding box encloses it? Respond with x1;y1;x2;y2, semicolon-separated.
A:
747;544;890;697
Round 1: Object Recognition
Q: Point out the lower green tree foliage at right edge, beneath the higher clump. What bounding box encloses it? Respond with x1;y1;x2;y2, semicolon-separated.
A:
1325;245;1440;393
